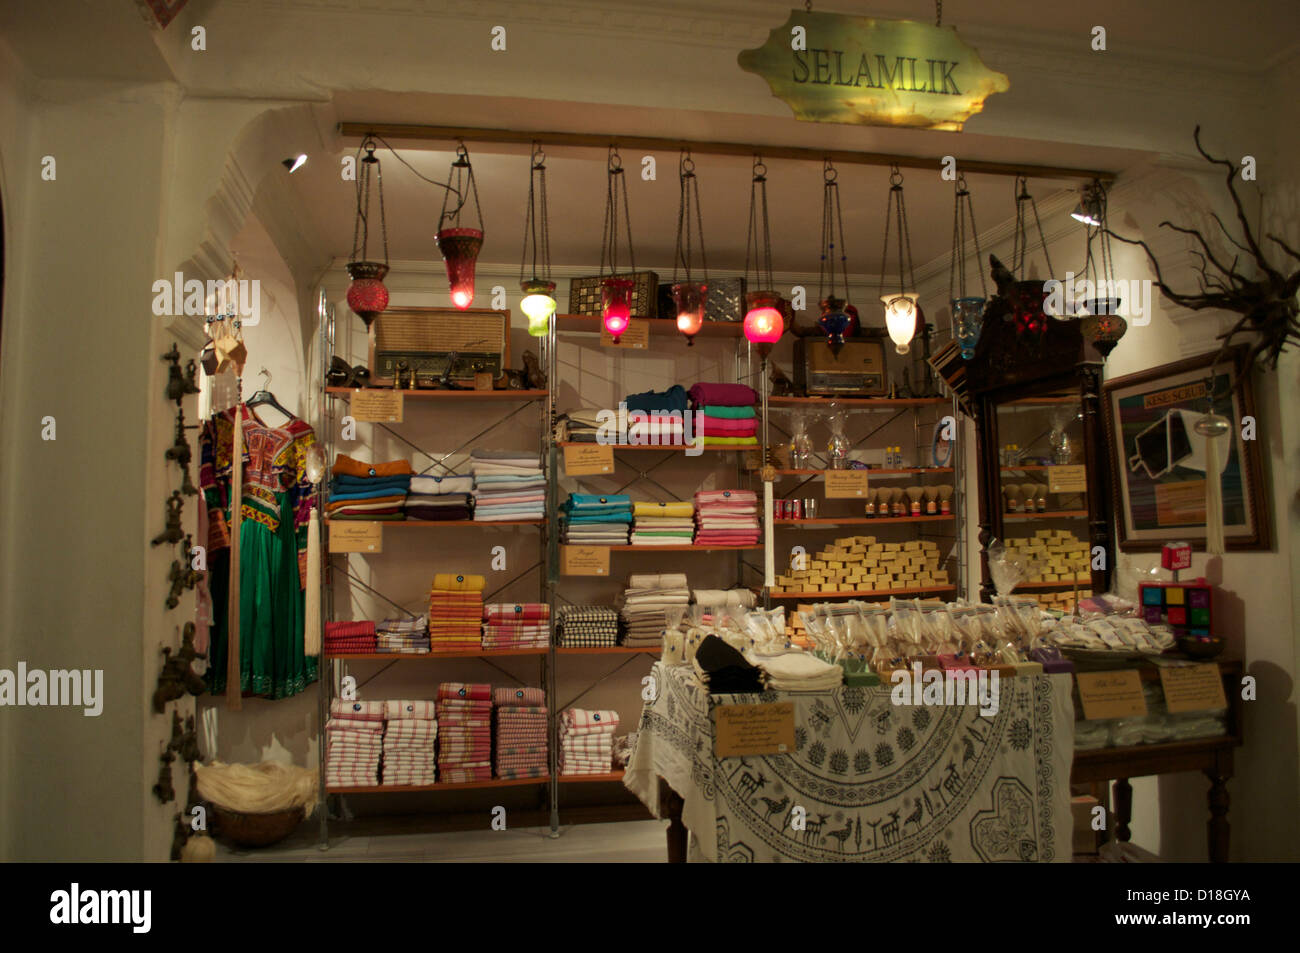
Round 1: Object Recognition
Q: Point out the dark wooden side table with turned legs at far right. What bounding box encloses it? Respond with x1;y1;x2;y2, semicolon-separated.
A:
1070;659;1243;863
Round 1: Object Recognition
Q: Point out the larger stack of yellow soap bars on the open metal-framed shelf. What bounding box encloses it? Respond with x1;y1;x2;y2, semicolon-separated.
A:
772;536;948;594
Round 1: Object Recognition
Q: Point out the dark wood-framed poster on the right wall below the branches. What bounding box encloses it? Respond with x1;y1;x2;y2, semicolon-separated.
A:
1102;348;1271;553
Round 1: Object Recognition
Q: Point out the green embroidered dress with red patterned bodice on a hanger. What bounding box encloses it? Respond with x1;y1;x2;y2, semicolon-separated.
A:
199;407;316;698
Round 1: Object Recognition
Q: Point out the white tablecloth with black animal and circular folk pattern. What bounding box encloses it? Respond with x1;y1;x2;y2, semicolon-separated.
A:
624;662;1074;863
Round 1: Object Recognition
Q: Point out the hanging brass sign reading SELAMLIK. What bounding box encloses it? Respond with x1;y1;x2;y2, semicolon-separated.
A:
737;10;1011;133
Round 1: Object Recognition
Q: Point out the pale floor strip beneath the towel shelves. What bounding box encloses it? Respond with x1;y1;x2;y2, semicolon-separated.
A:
216;820;668;863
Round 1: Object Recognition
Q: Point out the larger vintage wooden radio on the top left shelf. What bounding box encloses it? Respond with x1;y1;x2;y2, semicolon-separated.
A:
371;308;510;386
